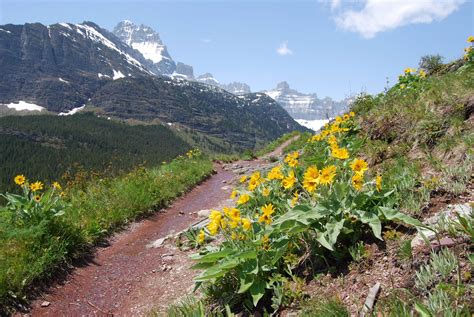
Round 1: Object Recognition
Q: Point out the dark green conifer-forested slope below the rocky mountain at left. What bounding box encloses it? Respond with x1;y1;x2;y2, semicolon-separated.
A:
0;113;190;192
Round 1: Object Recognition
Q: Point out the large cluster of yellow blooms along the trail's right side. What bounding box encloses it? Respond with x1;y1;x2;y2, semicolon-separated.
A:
198;112;382;249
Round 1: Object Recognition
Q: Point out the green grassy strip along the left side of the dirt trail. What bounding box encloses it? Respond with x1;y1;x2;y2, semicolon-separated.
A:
0;153;213;311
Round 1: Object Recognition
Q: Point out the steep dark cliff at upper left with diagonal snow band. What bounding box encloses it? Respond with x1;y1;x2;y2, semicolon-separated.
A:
0;22;151;112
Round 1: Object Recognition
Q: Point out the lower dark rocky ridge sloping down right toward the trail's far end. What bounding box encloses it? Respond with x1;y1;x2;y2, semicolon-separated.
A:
90;77;306;151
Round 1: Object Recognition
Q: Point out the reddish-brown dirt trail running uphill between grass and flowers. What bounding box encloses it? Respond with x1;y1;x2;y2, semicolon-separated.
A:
25;137;297;316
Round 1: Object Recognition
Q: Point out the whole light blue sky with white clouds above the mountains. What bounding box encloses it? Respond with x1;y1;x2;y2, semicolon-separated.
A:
0;0;474;99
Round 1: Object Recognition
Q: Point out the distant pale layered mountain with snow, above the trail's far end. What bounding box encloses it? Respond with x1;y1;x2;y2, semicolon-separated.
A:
264;82;348;120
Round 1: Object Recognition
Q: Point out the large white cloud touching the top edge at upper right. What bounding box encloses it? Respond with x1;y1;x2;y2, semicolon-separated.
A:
331;0;466;38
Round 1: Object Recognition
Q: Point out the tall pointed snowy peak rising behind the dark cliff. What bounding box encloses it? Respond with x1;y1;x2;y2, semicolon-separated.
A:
113;20;176;75
